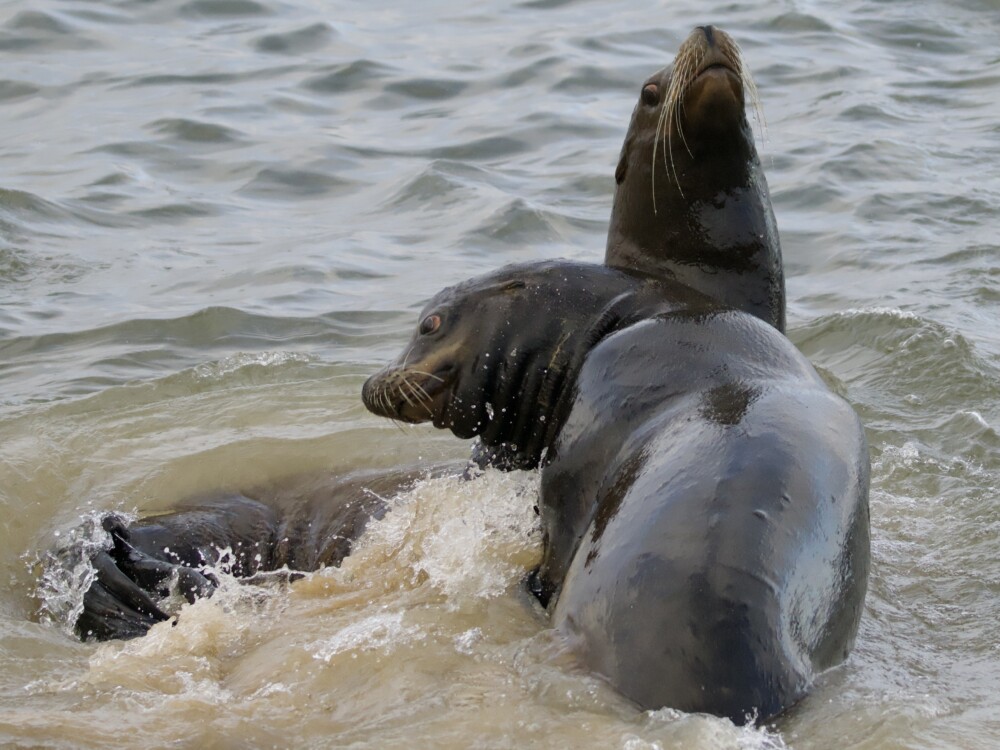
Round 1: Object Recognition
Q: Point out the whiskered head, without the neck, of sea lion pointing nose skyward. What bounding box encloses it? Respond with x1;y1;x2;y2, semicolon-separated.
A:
615;26;760;206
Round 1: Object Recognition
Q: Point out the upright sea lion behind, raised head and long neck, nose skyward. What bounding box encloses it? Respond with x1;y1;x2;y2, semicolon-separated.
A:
605;26;785;331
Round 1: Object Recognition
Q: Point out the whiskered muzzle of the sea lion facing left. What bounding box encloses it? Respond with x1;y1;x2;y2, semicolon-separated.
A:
361;366;454;424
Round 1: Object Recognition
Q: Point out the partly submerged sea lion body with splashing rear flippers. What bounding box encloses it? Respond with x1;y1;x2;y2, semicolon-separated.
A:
72;466;426;640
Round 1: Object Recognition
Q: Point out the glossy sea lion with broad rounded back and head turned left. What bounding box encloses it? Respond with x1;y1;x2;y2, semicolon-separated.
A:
362;262;870;723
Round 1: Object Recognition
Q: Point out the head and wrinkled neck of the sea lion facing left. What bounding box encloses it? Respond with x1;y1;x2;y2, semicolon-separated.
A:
362;262;651;469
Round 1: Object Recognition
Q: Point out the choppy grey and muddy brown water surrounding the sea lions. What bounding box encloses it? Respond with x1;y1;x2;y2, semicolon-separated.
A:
0;0;1000;749
